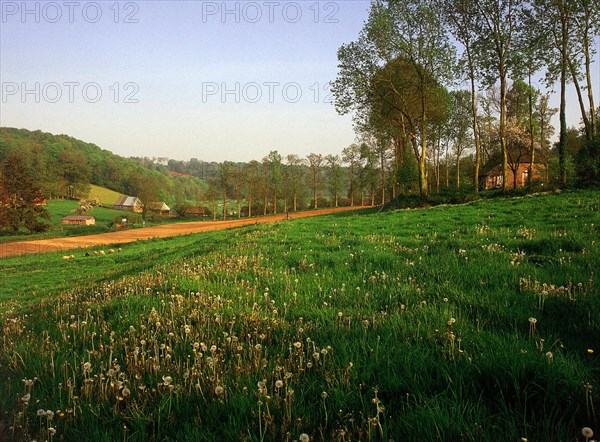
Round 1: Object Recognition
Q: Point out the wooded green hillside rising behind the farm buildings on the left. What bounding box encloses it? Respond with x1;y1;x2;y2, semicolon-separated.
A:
0;127;206;203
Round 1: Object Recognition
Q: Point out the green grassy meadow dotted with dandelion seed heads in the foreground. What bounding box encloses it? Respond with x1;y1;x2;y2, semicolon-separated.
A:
0;191;600;441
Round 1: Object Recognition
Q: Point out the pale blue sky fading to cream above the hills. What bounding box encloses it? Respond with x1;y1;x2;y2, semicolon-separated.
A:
0;0;600;161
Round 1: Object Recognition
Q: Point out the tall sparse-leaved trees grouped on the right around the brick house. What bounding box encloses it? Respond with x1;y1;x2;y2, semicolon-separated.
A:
333;0;600;198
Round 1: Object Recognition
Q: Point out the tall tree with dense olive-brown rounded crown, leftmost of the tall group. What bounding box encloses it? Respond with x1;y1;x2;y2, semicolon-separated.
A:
333;0;455;199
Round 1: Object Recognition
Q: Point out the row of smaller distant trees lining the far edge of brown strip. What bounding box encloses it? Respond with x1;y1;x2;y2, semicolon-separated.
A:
199;150;375;219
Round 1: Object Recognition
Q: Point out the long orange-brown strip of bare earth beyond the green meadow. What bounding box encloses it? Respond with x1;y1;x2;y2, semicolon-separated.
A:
0;207;360;257
